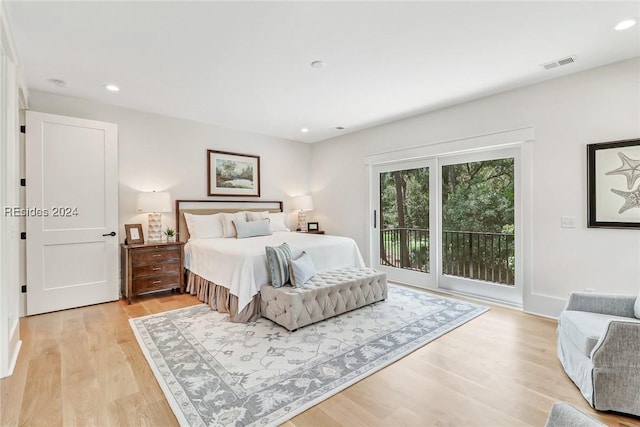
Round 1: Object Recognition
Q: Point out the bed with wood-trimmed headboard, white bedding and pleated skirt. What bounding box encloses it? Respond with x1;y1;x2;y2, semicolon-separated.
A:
176;200;364;322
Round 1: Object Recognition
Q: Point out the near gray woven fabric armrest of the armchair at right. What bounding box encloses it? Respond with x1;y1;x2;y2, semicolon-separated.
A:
591;320;640;369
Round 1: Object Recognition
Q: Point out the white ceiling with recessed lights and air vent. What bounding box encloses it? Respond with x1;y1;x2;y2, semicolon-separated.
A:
4;0;640;142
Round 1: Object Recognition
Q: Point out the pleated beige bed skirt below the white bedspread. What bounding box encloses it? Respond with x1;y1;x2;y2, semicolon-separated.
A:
186;270;261;323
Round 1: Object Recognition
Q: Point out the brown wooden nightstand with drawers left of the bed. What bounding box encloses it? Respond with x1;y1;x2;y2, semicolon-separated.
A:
120;242;184;304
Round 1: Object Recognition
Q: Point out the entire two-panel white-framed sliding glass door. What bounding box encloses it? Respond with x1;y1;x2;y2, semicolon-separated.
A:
372;149;522;304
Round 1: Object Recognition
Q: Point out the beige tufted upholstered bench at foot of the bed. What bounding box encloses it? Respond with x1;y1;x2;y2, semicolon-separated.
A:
260;267;387;331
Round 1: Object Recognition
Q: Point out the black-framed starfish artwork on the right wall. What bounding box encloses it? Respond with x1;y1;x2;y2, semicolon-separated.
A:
587;139;640;229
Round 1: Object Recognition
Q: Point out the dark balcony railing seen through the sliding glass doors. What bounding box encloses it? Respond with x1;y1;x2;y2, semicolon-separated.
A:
380;228;515;286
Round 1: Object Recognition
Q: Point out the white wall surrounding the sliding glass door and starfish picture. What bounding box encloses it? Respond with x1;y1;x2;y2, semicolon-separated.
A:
311;58;640;316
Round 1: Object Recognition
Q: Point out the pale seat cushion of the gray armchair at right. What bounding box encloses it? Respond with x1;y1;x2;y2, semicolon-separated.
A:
558;310;640;356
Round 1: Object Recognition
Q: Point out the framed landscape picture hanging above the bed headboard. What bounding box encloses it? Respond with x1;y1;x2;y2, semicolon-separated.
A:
207;150;260;197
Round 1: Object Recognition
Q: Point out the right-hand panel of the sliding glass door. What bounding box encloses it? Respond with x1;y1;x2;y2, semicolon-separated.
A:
438;150;522;304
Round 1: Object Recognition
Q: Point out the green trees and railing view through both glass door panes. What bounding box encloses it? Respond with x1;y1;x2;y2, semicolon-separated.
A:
380;159;515;285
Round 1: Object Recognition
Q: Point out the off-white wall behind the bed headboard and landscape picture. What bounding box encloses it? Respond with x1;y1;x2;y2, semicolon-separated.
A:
24;91;311;314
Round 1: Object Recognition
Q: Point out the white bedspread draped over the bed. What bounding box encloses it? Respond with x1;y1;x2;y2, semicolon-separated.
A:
184;232;364;312
